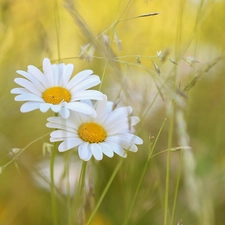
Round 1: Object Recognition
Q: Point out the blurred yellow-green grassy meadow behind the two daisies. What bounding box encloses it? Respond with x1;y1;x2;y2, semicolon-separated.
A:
0;0;225;225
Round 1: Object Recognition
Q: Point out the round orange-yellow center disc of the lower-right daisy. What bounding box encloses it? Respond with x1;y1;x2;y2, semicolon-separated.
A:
78;122;106;143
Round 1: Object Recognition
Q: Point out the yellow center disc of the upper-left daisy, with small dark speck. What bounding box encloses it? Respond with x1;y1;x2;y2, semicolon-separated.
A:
42;87;71;105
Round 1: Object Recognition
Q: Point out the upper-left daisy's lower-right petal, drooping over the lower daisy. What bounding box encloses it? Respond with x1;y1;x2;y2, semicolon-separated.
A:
65;102;97;117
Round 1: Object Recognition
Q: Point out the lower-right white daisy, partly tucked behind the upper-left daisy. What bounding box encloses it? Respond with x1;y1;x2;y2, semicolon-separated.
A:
46;95;143;161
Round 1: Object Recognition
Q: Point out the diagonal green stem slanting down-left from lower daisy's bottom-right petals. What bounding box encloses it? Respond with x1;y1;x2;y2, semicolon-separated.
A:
86;159;124;225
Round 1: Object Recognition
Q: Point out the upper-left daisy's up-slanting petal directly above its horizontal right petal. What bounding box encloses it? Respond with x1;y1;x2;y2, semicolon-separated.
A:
67;75;101;93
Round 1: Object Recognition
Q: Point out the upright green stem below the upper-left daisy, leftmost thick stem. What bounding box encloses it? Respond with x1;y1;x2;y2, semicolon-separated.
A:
50;142;58;225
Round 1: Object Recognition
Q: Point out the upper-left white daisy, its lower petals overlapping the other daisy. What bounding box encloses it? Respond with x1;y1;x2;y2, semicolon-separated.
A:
11;58;103;118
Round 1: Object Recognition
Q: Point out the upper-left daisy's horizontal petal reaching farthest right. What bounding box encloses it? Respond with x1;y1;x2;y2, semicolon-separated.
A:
71;90;103;101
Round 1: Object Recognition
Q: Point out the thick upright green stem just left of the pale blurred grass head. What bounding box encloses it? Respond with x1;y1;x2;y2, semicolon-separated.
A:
164;103;174;225
